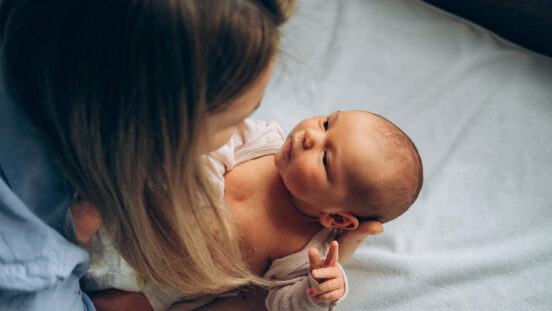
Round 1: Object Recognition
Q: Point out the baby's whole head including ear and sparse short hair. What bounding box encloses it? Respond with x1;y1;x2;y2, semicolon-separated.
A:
275;111;423;229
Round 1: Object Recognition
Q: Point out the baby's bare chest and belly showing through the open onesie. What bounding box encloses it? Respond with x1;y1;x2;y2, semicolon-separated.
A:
224;156;321;275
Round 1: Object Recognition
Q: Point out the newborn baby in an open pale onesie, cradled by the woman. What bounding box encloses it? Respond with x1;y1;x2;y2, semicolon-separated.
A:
77;111;423;310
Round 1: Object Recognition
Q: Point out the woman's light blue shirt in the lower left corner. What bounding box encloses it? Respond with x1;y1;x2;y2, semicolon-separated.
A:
0;81;95;310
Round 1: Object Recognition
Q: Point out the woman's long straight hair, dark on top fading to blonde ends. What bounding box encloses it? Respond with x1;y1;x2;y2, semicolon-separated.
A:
0;0;293;295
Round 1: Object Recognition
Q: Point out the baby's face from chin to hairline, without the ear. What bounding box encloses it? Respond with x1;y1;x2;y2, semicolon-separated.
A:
274;111;383;217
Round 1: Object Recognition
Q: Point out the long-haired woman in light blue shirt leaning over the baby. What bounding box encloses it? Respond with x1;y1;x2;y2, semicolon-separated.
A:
0;0;293;310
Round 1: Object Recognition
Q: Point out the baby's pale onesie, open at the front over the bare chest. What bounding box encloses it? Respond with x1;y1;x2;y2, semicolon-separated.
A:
83;120;349;311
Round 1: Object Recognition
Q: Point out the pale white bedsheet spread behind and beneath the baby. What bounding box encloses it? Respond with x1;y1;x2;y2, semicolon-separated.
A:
253;0;552;310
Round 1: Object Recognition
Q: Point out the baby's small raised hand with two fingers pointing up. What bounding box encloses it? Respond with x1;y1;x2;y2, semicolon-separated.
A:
307;241;345;302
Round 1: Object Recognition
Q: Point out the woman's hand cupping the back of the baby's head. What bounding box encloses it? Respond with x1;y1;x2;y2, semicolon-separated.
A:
337;220;383;265
